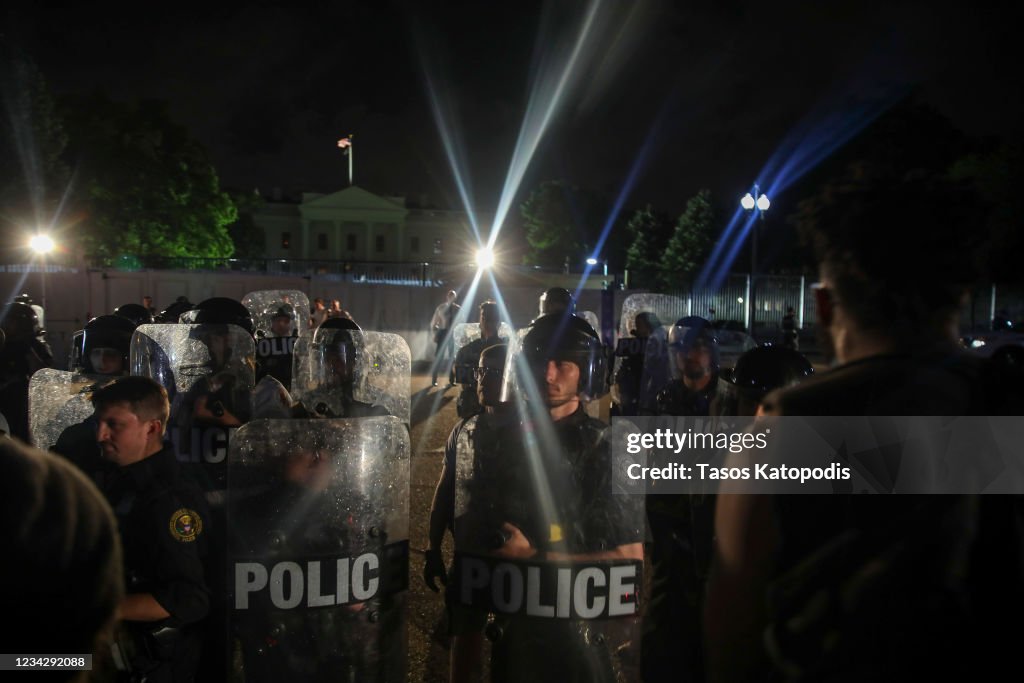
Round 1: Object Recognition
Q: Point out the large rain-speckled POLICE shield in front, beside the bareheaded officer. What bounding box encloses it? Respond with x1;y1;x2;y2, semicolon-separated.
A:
227;417;410;683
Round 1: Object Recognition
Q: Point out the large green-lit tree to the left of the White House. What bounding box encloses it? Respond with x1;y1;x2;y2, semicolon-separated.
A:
63;94;238;259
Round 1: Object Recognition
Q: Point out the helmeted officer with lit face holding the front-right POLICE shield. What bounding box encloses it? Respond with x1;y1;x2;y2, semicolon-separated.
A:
456;312;643;681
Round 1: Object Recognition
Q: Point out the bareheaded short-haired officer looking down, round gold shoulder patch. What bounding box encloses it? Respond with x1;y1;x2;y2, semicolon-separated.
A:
92;377;210;681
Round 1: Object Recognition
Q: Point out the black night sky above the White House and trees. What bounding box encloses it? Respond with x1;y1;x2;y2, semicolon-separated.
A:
3;0;1024;220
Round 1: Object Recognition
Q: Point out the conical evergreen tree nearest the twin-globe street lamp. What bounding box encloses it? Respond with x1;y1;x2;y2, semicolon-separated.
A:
659;189;717;290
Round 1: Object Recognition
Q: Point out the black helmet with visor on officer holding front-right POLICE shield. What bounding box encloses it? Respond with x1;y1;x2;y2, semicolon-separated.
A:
512;312;606;400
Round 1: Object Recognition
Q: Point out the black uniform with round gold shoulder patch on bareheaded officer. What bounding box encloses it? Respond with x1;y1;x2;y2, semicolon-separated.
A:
104;447;210;681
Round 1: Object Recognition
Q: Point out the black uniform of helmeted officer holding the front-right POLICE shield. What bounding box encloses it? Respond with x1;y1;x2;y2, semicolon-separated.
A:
467;408;644;682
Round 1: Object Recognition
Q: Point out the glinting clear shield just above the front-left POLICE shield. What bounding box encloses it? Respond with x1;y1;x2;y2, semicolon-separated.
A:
292;330;413;424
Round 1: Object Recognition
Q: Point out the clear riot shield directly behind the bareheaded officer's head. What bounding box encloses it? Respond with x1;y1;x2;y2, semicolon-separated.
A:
131;325;255;497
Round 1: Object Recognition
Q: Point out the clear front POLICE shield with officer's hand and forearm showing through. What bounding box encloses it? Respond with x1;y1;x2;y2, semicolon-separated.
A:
447;409;644;683
